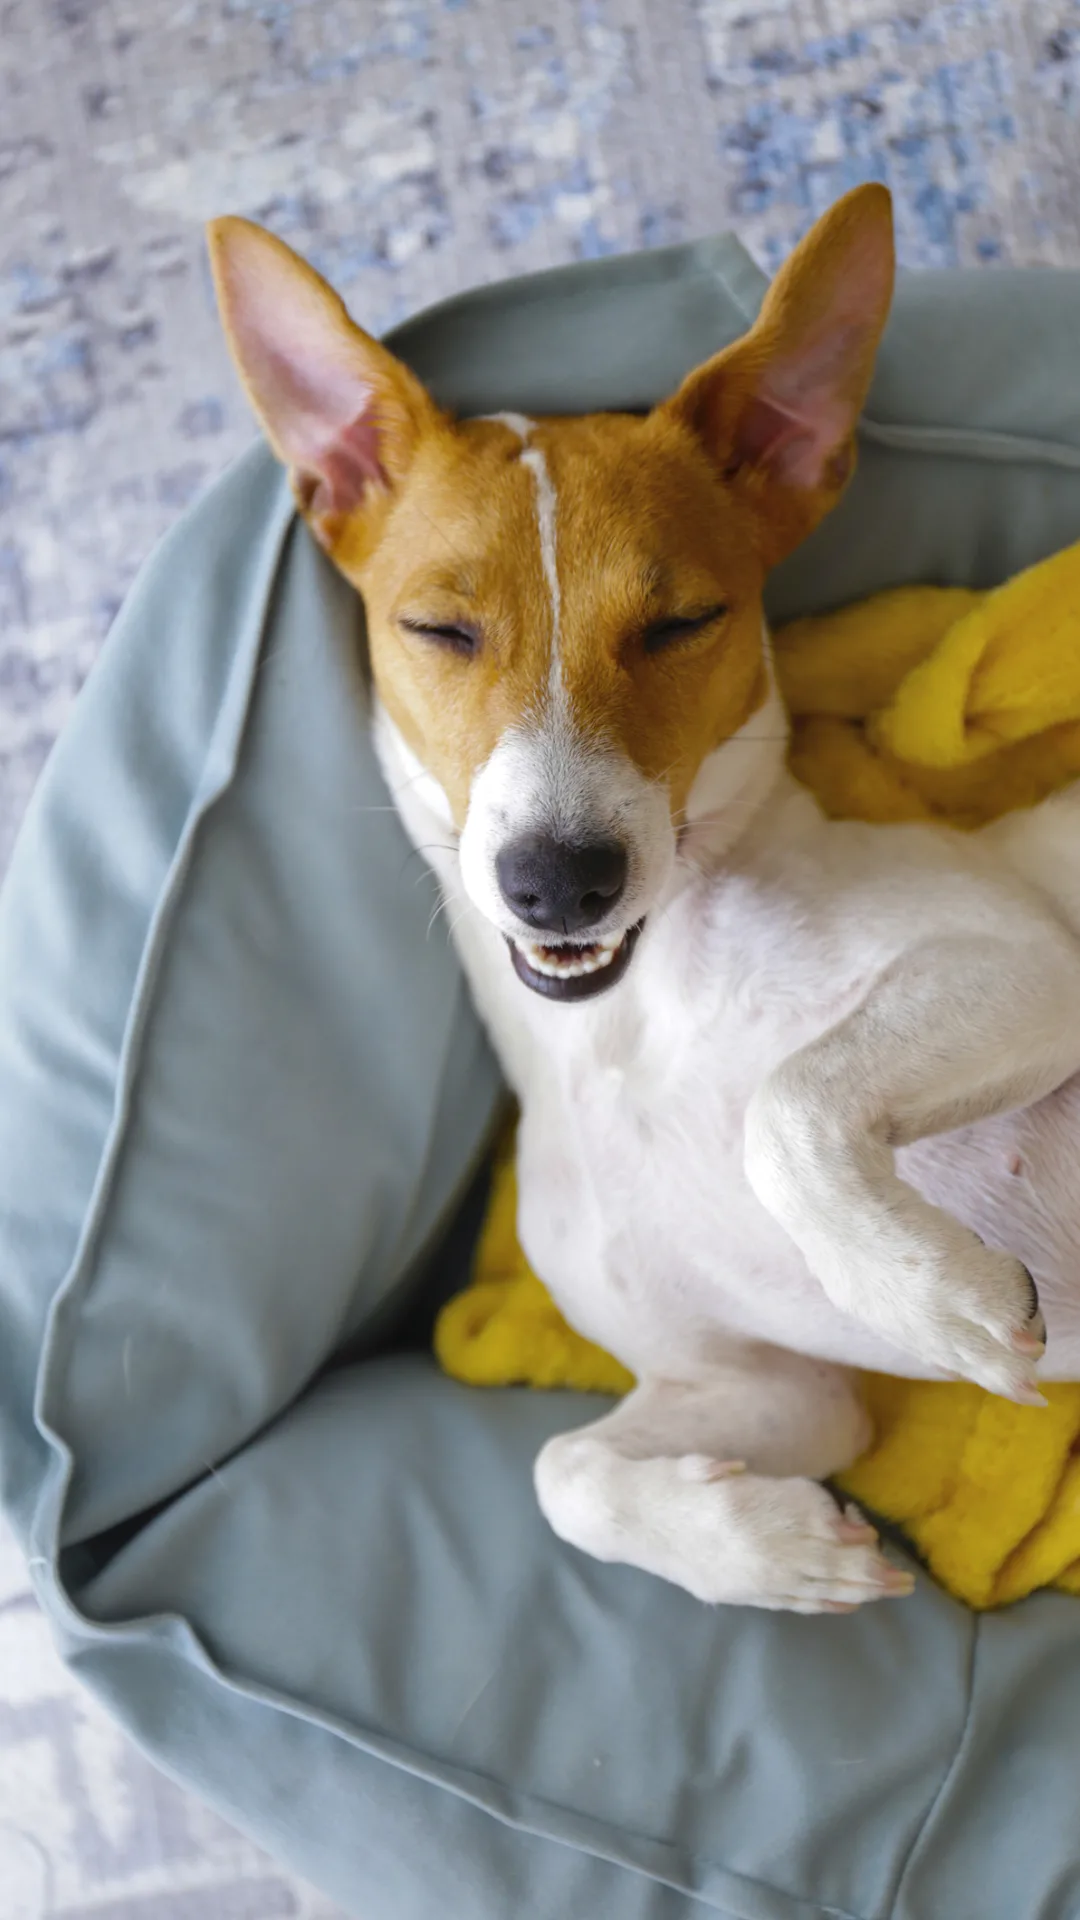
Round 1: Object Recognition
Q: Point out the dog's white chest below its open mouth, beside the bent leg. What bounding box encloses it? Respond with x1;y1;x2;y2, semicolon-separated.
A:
507;887;861;1371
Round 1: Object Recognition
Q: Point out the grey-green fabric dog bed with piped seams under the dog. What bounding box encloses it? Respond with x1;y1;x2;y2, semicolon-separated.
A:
0;238;1080;1920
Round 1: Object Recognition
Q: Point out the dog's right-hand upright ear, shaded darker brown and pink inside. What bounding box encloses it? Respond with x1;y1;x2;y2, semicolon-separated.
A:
661;186;894;566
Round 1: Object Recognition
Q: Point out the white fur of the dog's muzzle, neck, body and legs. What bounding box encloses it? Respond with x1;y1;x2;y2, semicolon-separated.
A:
372;641;1080;1611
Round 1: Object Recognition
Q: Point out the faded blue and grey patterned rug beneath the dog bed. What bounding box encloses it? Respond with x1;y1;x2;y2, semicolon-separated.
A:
0;0;1080;1920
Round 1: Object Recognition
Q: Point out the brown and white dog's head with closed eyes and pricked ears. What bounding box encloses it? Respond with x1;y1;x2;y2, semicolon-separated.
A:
211;186;894;998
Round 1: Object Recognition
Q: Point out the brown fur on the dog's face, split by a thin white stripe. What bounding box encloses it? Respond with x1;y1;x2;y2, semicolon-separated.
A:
334;415;765;820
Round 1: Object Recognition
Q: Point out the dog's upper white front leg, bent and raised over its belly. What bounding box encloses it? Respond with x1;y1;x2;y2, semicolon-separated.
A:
746;925;1080;1402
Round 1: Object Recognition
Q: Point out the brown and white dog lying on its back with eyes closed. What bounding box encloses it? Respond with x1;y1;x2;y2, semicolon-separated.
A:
209;186;1080;1613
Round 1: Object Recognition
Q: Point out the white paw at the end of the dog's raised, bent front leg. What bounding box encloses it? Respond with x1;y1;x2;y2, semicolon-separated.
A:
846;1223;1045;1407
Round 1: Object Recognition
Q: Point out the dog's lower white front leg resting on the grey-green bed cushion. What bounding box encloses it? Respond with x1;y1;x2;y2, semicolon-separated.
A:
536;1346;913;1613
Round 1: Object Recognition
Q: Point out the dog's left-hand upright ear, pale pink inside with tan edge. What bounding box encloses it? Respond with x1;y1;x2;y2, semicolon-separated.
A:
208;219;442;549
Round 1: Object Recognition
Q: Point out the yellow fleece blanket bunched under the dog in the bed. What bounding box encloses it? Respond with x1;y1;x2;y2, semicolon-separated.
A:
436;543;1080;1609
